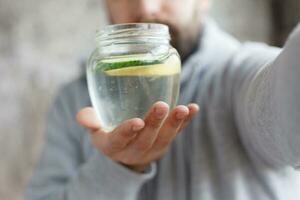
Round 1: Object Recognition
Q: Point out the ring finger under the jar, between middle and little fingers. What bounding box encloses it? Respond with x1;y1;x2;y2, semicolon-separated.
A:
152;105;189;149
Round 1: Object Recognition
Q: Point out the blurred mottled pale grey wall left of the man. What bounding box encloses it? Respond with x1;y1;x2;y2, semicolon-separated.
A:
0;0;104;200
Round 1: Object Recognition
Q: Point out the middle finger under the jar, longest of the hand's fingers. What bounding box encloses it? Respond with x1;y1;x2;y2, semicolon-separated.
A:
128;101;169;152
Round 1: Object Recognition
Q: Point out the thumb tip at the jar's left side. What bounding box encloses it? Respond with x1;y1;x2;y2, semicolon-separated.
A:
76;107;101;132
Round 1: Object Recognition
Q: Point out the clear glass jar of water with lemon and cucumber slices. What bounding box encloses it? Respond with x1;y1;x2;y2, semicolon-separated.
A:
86;23;181;131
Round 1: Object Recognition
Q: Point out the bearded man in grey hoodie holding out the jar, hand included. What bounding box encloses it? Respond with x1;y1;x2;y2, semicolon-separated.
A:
27;0;300;200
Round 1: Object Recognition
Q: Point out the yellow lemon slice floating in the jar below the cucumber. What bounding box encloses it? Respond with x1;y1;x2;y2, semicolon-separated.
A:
105;55;181;76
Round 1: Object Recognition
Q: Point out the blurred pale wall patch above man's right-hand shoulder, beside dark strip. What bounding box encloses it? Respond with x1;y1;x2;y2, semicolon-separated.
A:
211;0;272;43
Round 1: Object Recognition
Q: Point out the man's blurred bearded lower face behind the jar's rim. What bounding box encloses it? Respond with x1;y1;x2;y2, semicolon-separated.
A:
106;0;209;58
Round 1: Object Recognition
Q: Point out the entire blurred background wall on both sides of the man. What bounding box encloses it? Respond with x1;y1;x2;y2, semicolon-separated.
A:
0;0;300;200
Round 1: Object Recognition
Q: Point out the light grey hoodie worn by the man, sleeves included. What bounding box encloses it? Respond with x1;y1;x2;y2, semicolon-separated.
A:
26;23;300;200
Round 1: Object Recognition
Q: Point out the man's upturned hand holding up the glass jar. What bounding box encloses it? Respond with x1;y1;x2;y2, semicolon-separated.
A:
76;102;199;172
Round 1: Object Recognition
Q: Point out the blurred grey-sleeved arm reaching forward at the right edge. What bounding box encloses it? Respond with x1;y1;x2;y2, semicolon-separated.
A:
233;23;300;168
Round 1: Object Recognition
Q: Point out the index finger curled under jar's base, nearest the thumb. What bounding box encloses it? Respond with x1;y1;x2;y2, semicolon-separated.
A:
104;118;145;154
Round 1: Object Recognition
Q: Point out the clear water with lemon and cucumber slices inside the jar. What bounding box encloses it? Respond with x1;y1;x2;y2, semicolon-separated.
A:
87;54;180;131
